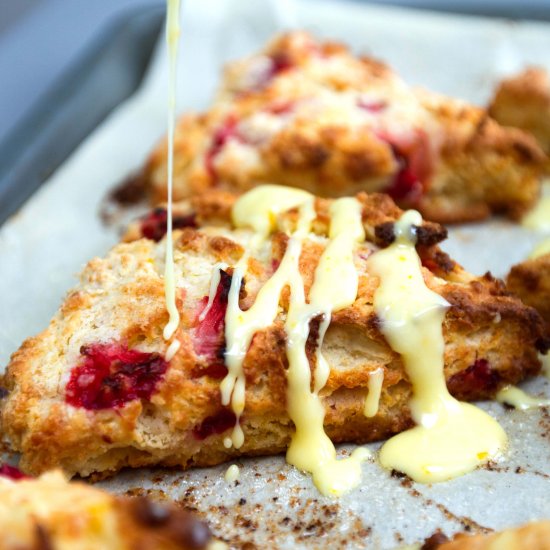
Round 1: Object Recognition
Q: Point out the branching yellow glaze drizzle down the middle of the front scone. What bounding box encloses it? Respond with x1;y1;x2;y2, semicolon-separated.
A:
221;185;369;495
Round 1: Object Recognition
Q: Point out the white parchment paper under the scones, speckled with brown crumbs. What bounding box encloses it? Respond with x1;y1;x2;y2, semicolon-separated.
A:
0;0;550;548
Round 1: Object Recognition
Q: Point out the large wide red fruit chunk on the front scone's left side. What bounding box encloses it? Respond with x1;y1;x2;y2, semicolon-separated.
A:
65;343;168;410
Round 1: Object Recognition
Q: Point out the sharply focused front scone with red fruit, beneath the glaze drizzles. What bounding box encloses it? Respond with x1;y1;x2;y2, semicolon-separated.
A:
2;192;544;475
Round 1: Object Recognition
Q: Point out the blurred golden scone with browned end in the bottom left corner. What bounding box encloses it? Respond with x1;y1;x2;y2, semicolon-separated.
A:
0;471;210;550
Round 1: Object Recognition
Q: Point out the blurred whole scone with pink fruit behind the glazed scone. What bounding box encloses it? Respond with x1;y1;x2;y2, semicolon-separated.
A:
142;32;546;223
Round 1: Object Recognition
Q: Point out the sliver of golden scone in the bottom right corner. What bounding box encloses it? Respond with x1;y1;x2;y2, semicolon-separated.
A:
433;520;550;550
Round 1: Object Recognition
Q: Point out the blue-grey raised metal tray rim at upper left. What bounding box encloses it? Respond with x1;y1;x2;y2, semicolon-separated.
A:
0;6;164;224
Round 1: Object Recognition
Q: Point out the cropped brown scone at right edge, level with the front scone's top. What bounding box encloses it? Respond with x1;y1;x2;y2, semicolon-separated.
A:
506;254;550;334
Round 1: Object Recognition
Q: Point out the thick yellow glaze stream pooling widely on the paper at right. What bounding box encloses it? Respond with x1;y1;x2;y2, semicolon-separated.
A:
368;210;507;483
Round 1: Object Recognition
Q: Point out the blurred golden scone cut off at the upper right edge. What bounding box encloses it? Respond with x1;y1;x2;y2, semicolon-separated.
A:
489;67;550;154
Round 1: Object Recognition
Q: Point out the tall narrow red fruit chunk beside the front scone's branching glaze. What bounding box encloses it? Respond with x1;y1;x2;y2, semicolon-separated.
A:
193;270;231;379
